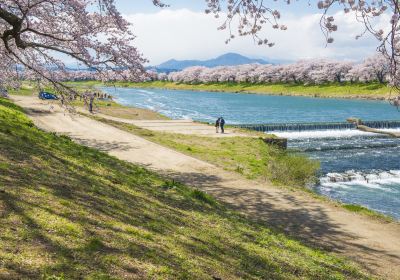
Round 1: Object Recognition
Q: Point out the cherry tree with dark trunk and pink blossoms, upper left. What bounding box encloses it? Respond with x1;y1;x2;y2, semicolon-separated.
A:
0;0;150;94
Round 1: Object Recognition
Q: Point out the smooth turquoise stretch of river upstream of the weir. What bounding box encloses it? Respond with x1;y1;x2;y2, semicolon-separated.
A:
104;88;400;124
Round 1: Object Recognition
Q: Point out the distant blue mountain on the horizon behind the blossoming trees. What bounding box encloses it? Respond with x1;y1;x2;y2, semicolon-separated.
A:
155;53;268;70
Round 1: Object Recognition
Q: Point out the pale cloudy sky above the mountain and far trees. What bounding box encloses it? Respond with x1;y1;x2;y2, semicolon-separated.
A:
116;0;388;65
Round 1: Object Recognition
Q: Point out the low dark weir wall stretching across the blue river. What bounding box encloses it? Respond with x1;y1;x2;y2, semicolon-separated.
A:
233;120;400;132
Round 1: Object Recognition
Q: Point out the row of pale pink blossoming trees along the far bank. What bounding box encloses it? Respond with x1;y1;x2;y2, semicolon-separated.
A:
155;55;390;84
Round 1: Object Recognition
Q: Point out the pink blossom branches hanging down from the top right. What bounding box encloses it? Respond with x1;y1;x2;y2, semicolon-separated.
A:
206;0;400;99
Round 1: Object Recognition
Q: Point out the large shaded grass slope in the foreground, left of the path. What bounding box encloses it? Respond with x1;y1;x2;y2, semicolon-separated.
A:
0;99;367;279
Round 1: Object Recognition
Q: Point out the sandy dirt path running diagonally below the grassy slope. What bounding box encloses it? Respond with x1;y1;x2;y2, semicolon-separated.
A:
14;96;400;279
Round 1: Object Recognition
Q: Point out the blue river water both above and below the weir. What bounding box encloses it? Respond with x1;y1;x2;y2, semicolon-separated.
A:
102;88;400;219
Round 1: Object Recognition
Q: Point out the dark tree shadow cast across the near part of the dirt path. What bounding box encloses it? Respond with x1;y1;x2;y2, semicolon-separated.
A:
160;168;400;273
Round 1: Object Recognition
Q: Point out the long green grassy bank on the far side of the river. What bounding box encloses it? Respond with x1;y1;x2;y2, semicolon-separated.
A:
67;81;390;100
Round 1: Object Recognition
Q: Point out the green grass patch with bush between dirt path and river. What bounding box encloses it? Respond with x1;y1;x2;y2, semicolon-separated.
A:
91;116;319;187
